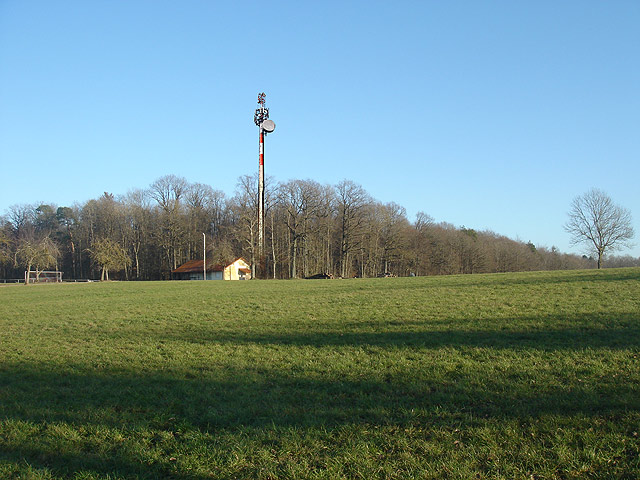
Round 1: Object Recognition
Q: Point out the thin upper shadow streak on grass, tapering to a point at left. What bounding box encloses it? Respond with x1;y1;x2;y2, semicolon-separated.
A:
150;313;640;351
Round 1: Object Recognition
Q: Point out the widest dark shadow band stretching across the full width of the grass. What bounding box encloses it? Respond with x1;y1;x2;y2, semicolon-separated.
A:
0;356;640;431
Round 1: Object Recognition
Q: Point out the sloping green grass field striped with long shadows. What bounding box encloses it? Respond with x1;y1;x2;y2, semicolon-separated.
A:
0;269;640;480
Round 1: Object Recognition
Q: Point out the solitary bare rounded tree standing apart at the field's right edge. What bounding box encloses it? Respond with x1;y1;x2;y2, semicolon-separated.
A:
564;188;634;268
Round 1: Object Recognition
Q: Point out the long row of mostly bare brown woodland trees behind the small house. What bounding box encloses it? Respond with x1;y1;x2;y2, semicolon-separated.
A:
0;175;640;280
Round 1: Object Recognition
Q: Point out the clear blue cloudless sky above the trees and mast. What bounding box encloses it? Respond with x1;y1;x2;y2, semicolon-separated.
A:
0;0;640;256
